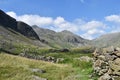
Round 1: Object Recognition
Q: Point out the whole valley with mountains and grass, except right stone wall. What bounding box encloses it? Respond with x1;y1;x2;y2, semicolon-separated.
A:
0;10;120;80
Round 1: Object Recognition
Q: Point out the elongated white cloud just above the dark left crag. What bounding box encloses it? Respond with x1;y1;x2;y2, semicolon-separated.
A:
7;11;53;26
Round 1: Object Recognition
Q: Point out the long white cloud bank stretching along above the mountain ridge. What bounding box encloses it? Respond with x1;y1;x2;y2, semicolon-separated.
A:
7;11;106;39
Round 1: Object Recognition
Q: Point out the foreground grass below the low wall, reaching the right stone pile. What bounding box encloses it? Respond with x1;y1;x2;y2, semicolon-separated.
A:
0;53;92;80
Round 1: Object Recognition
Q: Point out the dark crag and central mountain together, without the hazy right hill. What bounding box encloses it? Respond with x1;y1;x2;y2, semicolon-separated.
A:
0;10;90;48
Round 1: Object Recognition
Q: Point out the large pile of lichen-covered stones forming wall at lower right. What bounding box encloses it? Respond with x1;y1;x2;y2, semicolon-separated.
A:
93;47;120;80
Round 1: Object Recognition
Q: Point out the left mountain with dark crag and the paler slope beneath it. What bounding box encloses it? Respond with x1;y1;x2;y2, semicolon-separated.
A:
0;10;48;46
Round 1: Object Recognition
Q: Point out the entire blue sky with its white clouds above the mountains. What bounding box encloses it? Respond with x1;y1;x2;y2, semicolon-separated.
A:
0;0;120;39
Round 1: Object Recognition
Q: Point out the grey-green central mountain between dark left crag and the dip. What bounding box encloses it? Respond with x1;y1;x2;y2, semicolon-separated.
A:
32;25;88;48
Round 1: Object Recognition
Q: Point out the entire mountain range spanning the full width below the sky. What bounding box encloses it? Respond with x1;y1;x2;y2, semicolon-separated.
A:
0;10;120;48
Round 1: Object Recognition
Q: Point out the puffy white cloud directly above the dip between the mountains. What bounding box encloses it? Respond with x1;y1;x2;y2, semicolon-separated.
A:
81;20;107;39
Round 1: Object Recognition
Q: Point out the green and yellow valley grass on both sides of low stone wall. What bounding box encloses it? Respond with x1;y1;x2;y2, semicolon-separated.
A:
0;44;92;80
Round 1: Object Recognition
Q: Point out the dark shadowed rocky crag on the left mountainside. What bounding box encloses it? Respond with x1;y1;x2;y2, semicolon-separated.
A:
0;10;39;40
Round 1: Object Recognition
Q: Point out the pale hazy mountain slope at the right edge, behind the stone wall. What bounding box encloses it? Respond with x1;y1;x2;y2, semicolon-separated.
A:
91;32;120;47
